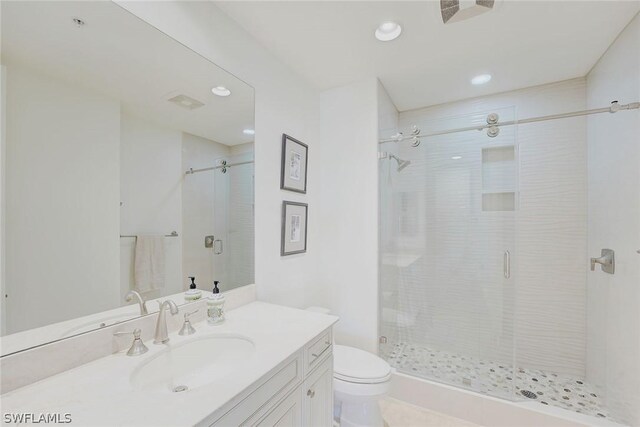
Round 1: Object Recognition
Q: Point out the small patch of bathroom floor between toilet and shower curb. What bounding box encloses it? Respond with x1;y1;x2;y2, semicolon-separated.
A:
380;398;477;427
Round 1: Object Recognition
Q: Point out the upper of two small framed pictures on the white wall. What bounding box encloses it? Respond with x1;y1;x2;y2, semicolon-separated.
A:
280;134;309;193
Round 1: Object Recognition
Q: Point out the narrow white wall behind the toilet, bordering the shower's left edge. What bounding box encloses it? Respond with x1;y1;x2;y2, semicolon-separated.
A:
320;79;378;352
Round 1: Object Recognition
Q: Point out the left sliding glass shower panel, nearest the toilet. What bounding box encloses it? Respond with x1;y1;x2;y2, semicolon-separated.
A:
379;108;518;399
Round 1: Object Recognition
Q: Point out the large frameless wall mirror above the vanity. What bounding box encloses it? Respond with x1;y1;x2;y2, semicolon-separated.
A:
0;1;254;355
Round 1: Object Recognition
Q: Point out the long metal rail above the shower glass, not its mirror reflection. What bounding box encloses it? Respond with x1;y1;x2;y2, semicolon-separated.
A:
378;101;640;144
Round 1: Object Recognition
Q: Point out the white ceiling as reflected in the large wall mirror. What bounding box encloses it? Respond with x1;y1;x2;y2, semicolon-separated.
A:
2;1;254;145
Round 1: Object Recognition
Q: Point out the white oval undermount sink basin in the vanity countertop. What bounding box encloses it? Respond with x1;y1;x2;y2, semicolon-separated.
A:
131;334;255;393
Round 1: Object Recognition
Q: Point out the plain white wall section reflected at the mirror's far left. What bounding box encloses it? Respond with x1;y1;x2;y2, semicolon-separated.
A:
5;66;120;333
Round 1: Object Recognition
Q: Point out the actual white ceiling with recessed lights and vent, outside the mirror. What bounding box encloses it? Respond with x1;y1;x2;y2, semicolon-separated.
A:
215;0;640;111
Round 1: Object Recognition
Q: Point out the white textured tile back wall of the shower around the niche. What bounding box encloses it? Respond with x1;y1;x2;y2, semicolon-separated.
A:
380;78;587;376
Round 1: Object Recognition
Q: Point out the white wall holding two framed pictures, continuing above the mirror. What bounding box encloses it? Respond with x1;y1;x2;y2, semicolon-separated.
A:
117;1;324;307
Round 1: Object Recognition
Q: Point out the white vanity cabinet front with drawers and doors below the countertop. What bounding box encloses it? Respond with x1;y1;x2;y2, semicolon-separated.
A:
208;329;333;427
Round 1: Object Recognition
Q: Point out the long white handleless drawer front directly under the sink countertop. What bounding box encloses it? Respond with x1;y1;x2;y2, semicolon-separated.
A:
212;353;303;427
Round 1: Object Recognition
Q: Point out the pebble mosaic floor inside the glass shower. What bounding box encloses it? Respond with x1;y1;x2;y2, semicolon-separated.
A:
384;342;616;421
